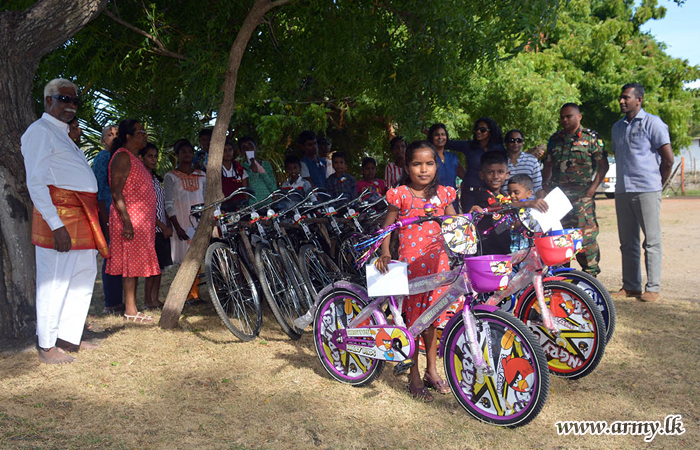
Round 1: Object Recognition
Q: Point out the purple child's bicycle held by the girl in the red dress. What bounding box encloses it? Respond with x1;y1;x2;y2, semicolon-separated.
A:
313;216;549;427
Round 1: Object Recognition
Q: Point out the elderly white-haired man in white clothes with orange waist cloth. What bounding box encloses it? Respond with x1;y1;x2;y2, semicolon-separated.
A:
22;78;109;364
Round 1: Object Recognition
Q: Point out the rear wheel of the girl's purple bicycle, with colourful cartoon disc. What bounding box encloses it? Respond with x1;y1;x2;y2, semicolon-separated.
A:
314;288;385;387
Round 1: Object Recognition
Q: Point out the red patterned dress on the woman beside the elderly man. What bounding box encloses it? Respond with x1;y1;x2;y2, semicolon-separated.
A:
106;148;160;278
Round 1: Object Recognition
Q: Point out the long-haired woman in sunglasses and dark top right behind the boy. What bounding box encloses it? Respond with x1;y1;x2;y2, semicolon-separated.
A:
445;117;505;211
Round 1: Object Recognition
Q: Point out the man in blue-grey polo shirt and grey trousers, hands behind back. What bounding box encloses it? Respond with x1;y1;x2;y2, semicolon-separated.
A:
612;83;673;302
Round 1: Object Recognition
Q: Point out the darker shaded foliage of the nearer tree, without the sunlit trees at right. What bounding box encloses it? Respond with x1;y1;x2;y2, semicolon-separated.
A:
30;0;558;177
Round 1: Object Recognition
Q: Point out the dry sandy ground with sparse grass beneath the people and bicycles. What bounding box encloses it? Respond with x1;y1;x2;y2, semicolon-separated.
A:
0;199;700;449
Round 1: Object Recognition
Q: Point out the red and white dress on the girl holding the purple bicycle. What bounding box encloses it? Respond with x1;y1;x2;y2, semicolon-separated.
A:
386;186;457;326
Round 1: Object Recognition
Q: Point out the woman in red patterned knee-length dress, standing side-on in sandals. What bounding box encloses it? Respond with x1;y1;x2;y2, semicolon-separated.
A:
107;119;160;323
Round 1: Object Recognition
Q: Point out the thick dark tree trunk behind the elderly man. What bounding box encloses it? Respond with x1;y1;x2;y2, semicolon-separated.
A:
0;0;107;338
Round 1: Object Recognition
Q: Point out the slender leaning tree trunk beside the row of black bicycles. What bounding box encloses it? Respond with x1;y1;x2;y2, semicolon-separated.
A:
159;0;291;329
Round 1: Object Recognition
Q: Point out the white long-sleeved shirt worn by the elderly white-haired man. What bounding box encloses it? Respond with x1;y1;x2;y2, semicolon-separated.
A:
22;113;97;231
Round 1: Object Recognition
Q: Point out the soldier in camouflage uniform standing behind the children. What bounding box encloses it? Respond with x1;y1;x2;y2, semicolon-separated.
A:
542;103;608;276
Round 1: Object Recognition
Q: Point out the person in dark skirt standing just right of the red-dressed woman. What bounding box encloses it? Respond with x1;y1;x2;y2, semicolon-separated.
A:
139;142;173;309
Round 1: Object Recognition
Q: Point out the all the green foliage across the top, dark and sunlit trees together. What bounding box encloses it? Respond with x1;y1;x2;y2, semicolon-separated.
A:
26;0;700;174
